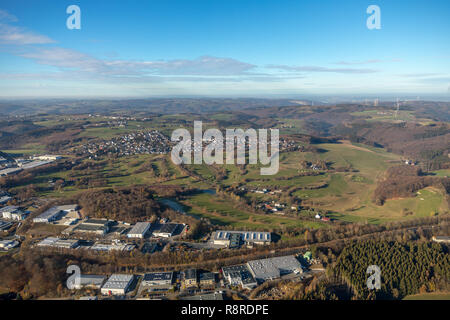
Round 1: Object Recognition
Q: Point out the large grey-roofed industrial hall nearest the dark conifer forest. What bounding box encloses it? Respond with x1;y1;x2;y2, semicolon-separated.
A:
247;256;303;283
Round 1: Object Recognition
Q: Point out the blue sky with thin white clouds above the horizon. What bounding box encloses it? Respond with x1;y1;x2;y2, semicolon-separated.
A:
0;0;450;97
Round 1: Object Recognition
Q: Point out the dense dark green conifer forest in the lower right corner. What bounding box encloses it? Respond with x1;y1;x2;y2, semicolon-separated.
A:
332;241;450;299
